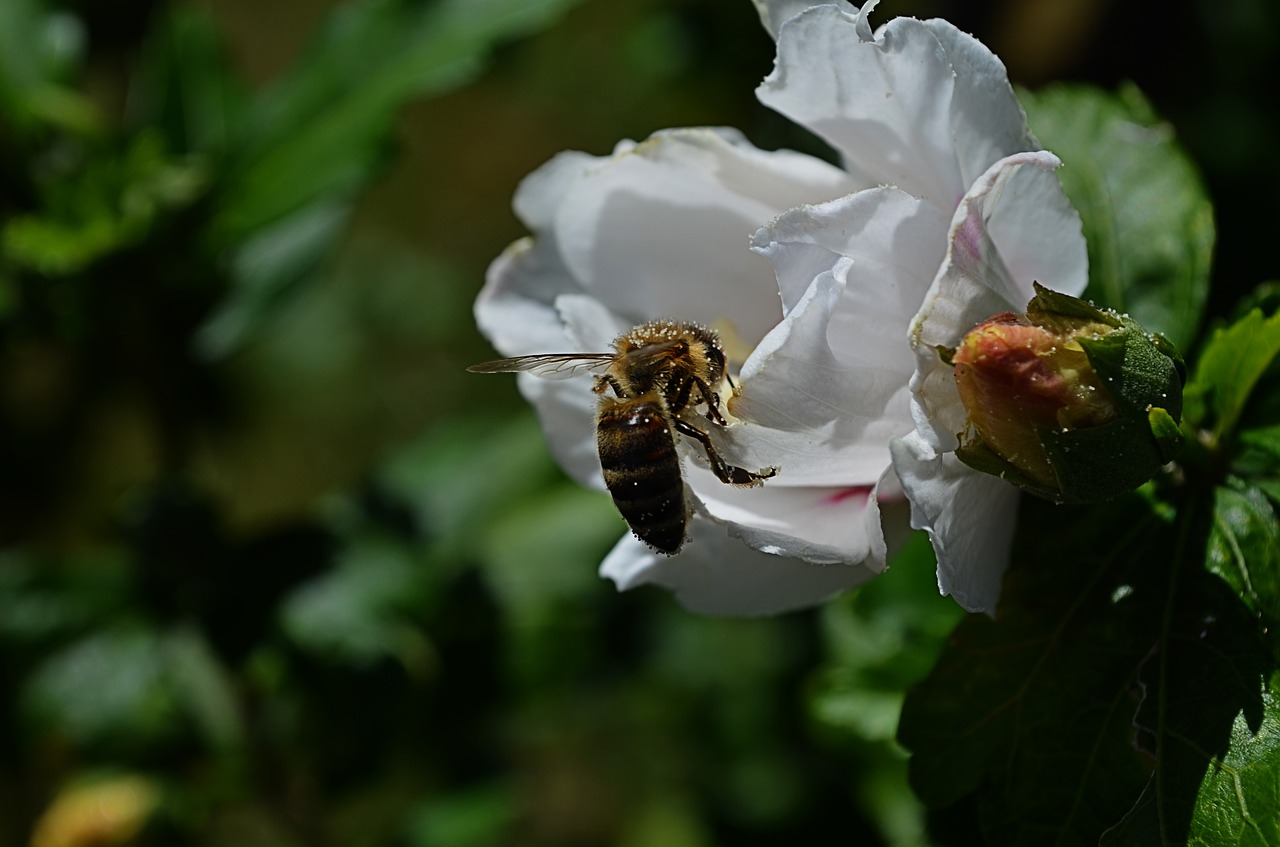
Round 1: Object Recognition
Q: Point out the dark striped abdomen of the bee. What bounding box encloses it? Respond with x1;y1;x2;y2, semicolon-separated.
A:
595;397;689;554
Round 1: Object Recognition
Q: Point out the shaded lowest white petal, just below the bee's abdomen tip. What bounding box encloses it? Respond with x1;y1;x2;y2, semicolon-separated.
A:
600;519;873;615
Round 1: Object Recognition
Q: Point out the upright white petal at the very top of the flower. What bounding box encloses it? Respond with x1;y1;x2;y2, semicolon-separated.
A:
756;6;1036;210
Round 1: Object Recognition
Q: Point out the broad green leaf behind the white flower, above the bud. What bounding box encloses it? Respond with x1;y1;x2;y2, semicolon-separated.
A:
1020;87;1215;349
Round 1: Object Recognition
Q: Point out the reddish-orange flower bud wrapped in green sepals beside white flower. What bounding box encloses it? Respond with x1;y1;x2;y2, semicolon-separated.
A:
943;283;1187;503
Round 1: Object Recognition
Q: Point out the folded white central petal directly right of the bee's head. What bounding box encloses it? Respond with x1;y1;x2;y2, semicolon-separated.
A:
710;188;946;487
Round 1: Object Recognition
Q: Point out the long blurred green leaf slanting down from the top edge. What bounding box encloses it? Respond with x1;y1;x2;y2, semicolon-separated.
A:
219;0;588;241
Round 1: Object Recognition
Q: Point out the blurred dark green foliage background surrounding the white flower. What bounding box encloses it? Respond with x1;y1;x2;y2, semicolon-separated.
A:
0;0;1280;847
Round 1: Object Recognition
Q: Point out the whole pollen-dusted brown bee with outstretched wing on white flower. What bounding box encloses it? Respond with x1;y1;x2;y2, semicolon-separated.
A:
467;320;778;555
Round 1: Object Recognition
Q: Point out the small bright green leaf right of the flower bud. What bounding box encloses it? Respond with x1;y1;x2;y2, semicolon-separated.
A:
1185;310;1280;441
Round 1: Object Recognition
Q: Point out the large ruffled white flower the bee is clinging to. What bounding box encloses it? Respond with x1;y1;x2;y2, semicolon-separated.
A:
476;0;1085;614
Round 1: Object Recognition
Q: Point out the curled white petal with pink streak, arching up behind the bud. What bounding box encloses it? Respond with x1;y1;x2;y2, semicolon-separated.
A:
911;152;1088;452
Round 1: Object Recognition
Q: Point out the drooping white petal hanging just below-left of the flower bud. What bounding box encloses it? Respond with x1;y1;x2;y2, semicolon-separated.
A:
892;432;1019;614
